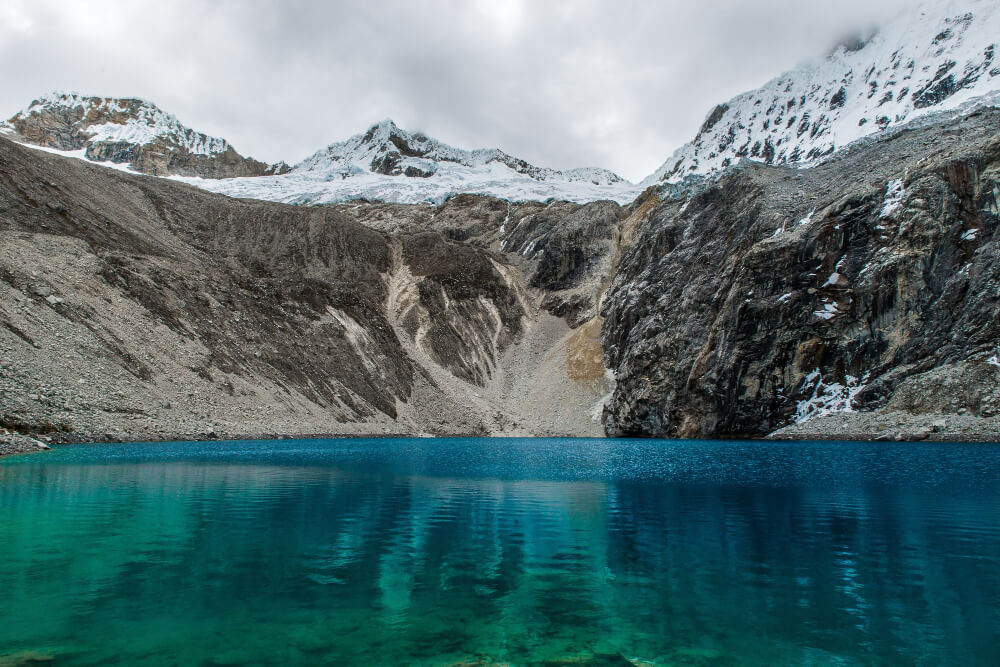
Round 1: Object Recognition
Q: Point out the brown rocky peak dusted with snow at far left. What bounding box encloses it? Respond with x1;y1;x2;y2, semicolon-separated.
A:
0;93;288;178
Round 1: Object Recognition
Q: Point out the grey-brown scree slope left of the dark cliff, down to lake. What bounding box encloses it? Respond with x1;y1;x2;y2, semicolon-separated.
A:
0;139;618;440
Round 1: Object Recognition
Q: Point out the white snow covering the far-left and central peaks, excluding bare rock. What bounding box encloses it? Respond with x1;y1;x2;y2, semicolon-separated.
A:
2;98;642;204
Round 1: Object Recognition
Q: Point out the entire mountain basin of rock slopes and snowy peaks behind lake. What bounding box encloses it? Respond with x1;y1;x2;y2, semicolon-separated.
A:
0;0;1000;453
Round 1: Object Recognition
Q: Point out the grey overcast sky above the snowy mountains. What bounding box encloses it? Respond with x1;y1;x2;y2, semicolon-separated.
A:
0;0;913;180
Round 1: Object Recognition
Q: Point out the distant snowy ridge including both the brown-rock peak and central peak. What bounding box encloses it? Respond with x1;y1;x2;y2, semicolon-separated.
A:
0;93;639;204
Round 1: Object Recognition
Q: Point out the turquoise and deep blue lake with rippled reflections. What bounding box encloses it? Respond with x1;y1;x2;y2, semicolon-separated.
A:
0;439;1000;666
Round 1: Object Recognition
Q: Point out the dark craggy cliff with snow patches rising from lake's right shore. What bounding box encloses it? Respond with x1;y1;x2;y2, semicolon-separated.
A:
602;109;1000;437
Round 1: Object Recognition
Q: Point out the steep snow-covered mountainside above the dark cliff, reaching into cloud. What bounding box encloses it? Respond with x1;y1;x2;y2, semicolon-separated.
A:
643;0;1000;185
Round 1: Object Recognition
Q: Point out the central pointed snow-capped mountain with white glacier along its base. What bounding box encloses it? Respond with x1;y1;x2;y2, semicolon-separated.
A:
175;120;639;204
